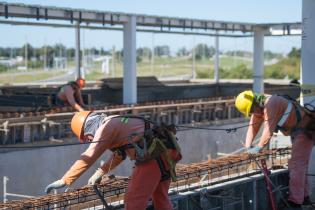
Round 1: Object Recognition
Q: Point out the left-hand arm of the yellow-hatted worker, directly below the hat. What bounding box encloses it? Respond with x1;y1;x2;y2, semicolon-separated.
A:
245;114;264;148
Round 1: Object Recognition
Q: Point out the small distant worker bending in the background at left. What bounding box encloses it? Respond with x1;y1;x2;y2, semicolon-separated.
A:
56;78;85;111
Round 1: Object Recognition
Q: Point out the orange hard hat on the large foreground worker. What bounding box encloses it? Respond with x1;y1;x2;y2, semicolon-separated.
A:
71;111;91;142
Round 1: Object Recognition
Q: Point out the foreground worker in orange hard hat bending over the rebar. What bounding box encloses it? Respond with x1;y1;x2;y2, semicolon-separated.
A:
45;111;181;210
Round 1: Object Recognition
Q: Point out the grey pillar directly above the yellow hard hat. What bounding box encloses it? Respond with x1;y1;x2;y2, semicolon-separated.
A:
253;28;264;93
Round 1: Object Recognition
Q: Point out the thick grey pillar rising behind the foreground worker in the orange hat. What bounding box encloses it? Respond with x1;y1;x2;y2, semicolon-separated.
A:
123;16;137;104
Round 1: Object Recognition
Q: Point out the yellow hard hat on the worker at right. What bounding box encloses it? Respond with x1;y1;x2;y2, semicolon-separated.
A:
235;90;254;117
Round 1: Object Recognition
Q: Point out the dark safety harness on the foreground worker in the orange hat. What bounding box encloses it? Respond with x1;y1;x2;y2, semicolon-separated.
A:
111;115;181;181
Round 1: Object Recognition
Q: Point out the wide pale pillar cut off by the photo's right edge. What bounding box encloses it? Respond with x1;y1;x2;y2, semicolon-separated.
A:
301;0;315;106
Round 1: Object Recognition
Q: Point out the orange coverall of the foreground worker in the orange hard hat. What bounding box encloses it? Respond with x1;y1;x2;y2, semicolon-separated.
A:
62;116;177;210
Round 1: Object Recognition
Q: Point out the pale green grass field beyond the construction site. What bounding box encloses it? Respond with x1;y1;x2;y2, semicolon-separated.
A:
0;56;252;85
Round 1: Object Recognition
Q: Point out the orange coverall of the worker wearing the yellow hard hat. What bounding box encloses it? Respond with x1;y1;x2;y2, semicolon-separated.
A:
245;96;315;204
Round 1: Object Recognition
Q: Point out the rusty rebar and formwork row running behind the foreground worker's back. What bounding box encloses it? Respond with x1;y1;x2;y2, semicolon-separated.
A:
0;98;241;147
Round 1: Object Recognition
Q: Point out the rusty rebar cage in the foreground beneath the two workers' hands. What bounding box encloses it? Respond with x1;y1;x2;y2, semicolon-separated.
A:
0;148;291;209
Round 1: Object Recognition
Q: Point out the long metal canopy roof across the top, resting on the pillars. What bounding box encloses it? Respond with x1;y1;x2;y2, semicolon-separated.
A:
0;2;301;37
